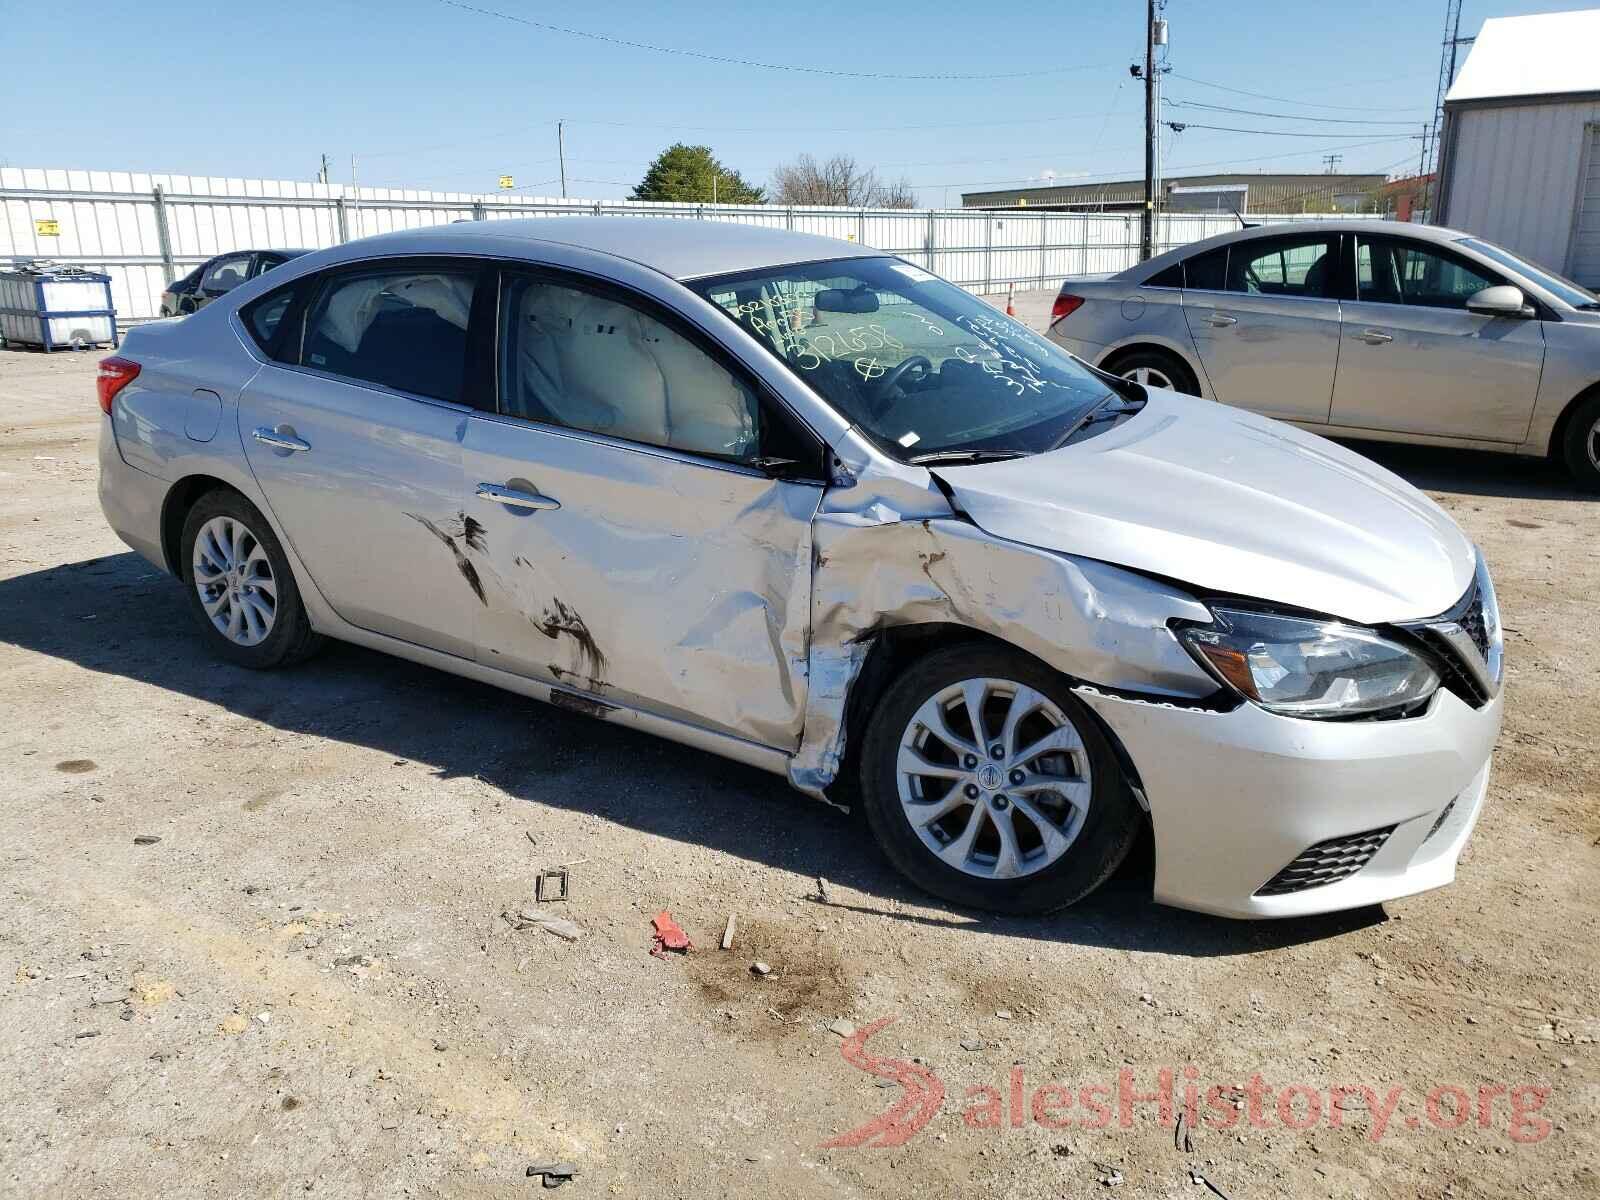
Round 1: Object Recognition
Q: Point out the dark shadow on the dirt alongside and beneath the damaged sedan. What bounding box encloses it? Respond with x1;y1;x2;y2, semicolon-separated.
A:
0;554;1384;957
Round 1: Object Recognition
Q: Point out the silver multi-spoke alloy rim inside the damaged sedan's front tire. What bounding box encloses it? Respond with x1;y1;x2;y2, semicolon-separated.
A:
896;678;1093;880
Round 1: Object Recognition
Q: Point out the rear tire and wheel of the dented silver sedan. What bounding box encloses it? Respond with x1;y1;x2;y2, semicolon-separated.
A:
179;490;322;670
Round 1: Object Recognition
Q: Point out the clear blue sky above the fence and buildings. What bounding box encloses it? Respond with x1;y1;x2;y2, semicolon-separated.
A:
0;0;1594;205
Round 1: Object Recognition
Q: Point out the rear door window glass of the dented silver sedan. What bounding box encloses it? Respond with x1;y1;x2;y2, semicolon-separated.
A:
301;267;475;403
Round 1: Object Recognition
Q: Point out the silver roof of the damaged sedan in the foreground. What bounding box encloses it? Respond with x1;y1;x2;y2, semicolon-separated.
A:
331;216;883;280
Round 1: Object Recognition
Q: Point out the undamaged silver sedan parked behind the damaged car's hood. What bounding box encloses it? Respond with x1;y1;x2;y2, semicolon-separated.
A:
1050;221;1600;491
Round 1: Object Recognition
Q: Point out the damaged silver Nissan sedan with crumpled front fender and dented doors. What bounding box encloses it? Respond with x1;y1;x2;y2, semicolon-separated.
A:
99;218;1501;917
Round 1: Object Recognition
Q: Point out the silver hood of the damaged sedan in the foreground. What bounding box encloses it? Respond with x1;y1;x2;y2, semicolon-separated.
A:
934;389;1477;624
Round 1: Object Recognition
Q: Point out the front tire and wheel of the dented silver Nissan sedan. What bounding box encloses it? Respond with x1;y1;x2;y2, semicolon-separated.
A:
861;645;1142;914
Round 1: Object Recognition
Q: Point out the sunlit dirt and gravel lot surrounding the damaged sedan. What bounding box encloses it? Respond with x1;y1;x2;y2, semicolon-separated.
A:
0;320;1600;1200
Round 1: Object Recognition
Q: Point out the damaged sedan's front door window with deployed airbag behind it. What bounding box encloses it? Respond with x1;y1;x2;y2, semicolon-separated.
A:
499;277;762;462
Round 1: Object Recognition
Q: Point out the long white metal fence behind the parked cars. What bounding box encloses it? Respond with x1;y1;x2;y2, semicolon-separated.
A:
0;166;1376;320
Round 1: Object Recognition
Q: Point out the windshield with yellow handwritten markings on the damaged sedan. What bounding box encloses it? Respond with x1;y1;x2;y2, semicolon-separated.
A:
690;258;1112;462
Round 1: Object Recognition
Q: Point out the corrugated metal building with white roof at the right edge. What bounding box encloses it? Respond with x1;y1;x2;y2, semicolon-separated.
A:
1437;8;1600;286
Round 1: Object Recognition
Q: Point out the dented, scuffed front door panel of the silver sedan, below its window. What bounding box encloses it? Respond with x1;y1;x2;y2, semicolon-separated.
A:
464;413;821;749
